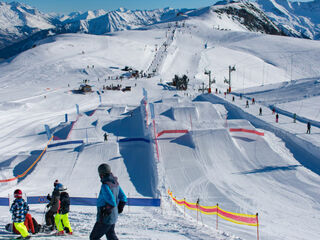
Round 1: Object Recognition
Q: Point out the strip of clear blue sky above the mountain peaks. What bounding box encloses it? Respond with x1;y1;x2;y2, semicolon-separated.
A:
0;0;308;13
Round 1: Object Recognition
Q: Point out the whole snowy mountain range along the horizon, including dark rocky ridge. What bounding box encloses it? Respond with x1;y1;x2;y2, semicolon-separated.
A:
0;0;320;58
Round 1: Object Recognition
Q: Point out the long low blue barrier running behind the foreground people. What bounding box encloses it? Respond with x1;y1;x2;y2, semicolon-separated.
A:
0;196;161;207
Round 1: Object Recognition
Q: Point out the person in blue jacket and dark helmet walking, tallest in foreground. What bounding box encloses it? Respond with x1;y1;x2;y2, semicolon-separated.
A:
90;163;127;240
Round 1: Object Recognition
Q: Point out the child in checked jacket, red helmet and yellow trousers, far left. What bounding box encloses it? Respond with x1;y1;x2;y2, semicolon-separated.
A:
10;189;30;239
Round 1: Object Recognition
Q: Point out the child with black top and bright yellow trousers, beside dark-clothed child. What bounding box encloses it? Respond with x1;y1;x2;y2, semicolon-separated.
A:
54;183;72;236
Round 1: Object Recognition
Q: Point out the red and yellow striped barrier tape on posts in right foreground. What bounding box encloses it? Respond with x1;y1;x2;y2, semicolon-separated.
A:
168;190;259;240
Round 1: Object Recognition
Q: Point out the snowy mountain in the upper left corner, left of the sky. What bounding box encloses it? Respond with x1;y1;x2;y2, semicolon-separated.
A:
0;2;60;49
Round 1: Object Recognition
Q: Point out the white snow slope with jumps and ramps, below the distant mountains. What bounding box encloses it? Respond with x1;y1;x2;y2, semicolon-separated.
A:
0;6;320;240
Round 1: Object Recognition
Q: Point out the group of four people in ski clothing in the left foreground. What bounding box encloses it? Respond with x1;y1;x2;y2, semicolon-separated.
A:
10;163;127;240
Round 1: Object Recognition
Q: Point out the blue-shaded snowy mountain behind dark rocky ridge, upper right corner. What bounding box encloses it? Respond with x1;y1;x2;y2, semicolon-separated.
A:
257;0;320;40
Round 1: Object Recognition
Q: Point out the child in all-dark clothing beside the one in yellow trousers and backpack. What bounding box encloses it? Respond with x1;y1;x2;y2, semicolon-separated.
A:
44;180;60;231
